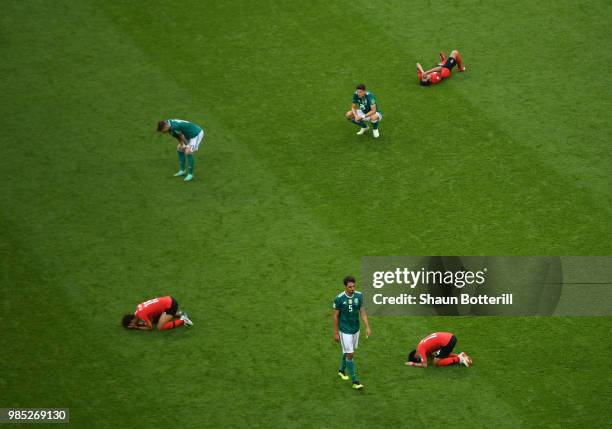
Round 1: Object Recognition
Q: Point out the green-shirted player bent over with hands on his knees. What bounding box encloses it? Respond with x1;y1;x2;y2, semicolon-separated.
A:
157;119;204;182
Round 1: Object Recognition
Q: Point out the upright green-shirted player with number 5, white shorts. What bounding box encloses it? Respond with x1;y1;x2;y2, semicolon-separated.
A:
333;276;372;390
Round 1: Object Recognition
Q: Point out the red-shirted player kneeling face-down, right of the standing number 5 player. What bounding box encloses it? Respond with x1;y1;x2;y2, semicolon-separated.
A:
406;332;472;368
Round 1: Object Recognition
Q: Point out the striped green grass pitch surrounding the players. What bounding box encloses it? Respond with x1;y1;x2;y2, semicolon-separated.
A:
0;0;612;428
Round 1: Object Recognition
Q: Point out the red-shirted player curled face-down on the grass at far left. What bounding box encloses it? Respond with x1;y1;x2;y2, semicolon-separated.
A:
121;296;193;331
